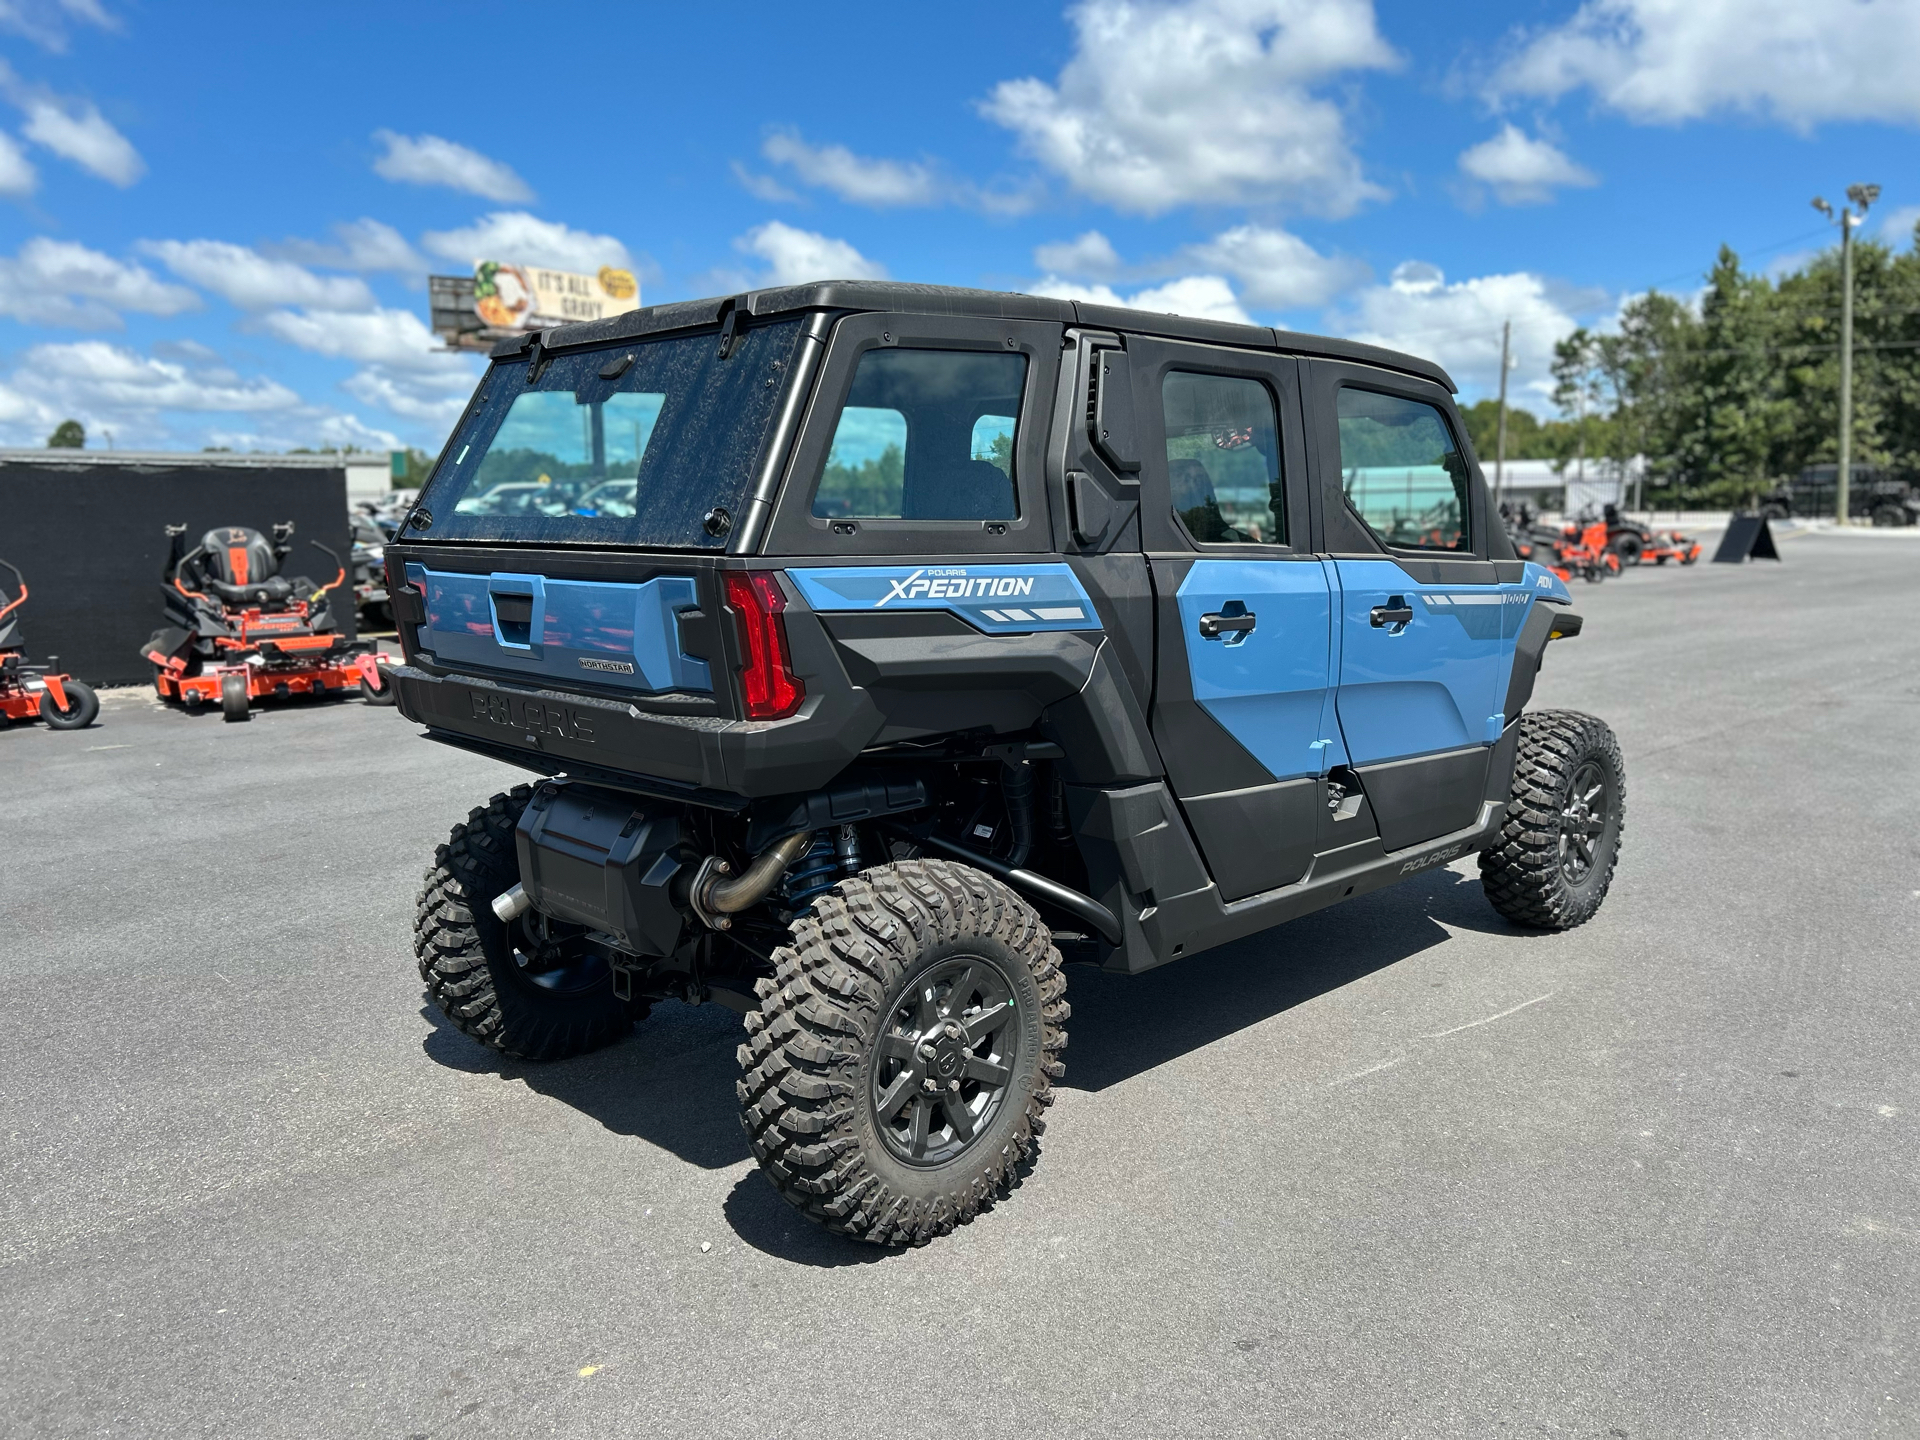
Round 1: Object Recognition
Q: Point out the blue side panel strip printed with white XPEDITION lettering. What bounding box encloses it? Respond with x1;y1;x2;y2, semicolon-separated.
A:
787;563;1100;636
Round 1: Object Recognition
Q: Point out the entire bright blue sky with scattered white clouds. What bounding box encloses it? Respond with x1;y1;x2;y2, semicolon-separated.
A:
0;0;1920;449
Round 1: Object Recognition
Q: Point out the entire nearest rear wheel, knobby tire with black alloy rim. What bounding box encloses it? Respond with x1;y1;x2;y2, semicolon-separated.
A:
739;860;1069;1244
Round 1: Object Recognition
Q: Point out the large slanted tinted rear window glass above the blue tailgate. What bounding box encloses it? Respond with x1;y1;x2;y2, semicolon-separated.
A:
407;321;801;549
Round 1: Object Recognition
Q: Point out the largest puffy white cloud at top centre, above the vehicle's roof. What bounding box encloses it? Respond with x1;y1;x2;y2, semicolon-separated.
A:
981;0;1398;215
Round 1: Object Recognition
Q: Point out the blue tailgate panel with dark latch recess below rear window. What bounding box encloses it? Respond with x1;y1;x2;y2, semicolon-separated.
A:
407;563;712;693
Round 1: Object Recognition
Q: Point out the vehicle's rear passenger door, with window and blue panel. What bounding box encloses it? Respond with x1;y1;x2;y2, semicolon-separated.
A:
1127;336;1331;900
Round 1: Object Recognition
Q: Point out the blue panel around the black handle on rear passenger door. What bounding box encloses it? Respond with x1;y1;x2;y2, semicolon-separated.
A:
1177;559;1332;780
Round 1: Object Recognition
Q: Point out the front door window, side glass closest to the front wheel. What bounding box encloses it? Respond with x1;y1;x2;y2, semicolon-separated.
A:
1340;388;1473;549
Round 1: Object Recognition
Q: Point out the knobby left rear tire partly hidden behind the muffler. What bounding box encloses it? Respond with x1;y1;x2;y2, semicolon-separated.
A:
413;785;647;1060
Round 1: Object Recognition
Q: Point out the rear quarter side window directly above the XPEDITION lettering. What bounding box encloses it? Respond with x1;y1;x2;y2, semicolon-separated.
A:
814;349;1027;520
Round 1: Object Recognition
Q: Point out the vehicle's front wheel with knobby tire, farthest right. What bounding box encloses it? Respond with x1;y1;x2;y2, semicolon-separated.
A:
1480;710;1626;929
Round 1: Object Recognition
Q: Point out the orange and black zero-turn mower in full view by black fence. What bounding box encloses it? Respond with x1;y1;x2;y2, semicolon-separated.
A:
140;522;394;720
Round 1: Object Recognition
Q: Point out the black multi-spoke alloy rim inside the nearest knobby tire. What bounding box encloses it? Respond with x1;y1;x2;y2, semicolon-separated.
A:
868;954;1020;1165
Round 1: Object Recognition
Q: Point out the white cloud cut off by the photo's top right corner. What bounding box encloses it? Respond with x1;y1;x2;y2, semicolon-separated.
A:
1488;0;1920;129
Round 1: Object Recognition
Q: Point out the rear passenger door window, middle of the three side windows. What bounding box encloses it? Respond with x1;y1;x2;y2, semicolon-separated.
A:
1160;371;1286;545
